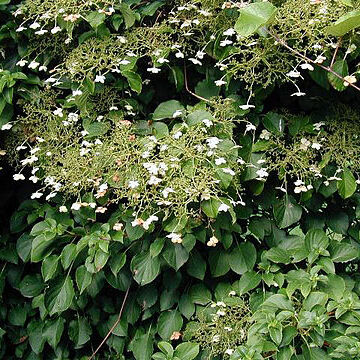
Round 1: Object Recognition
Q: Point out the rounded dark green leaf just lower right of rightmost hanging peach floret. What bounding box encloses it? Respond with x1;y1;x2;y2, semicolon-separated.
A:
229;242;256;275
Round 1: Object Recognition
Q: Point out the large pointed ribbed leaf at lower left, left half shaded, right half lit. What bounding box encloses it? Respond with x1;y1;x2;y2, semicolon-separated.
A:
45;276;75;316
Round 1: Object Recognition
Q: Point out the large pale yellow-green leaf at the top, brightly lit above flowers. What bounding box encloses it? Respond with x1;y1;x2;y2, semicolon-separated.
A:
234;2;277;36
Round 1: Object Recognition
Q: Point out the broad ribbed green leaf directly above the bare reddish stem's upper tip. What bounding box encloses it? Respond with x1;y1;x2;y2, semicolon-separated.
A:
130;251;160;286
